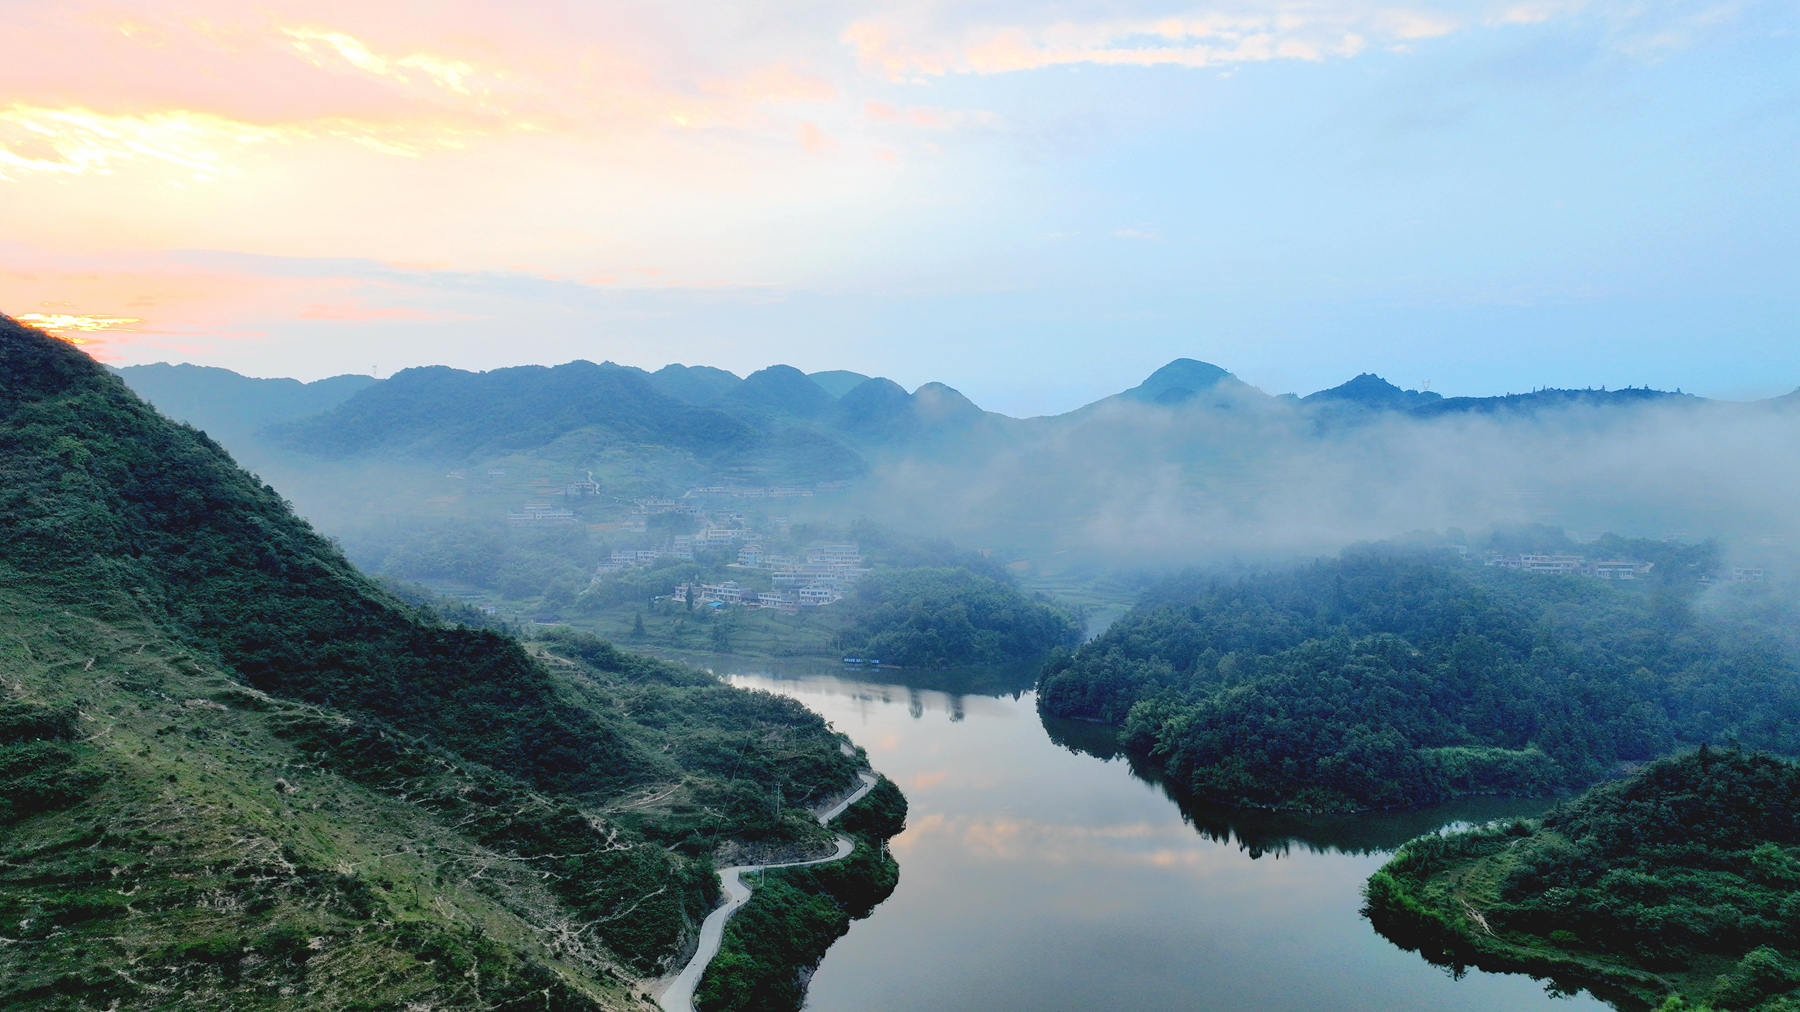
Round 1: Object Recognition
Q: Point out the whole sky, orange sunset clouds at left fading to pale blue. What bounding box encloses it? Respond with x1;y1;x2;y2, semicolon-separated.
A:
0;0;1800;414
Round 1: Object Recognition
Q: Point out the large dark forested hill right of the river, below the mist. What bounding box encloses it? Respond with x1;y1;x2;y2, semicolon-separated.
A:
1039;544;1800;810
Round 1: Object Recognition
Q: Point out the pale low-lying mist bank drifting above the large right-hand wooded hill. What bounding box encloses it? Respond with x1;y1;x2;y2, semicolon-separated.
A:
842;392;1800;567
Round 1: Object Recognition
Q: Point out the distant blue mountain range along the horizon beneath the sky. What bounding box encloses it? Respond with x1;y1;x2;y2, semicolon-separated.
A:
117;358;1778;477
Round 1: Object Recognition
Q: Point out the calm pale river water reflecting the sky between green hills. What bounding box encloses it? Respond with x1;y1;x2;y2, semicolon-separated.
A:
722;664;1607;1012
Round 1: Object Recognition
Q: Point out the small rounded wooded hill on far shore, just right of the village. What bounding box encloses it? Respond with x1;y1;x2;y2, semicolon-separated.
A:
835;569;1080;668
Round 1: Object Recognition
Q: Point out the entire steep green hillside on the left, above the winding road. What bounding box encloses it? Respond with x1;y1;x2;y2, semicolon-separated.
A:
0;317;900;1008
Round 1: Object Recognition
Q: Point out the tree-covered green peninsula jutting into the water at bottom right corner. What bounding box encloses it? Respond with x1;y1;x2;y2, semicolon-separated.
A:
1364;747;1800;1012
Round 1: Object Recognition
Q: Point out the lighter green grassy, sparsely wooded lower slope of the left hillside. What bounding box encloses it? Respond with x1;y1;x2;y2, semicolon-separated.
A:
0;589;666;1010
